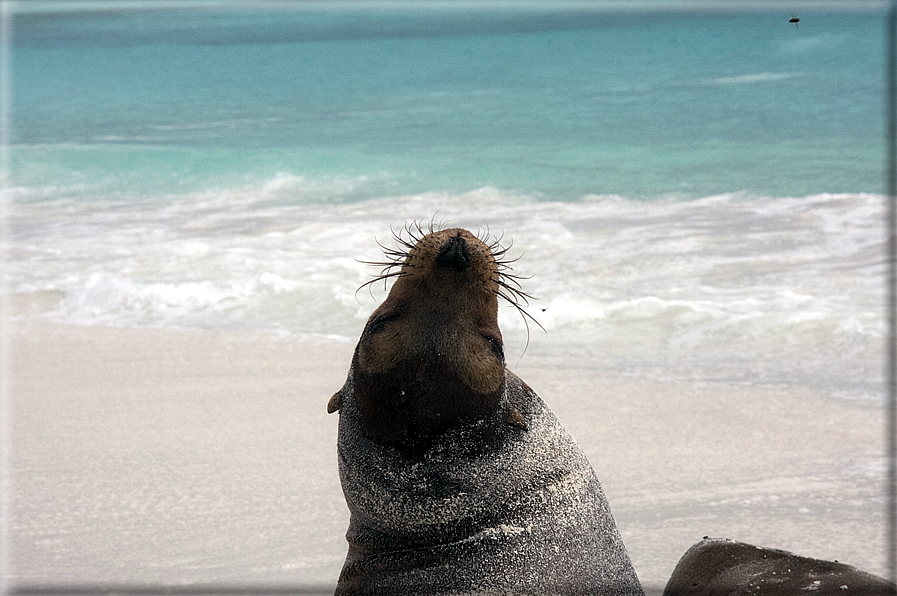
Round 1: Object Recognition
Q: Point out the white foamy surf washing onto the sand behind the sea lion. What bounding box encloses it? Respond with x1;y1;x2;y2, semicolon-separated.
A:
5;175;885;400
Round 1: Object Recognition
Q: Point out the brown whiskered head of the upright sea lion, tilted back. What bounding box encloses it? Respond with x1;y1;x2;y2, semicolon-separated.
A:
328;228;525;446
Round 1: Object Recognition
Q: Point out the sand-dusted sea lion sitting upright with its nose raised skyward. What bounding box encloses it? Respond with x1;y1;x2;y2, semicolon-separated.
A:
327;227;643;596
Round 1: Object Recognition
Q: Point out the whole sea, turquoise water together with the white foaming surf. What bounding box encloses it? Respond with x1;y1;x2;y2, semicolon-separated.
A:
4;0;885;399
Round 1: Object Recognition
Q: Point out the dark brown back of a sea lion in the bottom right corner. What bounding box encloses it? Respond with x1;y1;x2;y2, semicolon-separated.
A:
663;538;897;596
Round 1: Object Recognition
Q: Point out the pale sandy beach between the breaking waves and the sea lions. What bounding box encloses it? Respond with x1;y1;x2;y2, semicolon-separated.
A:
7;321;886;590
